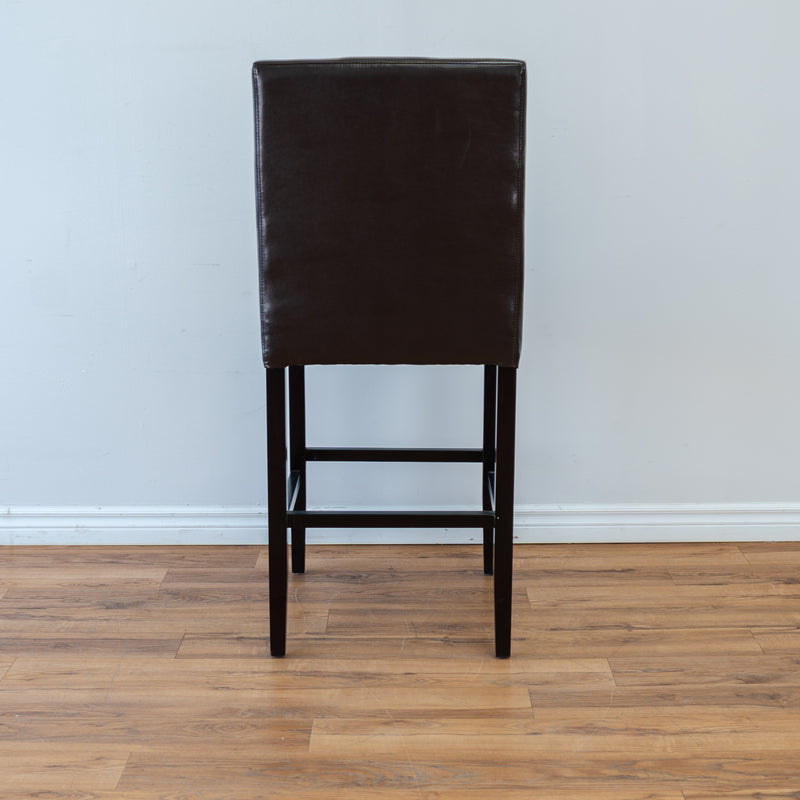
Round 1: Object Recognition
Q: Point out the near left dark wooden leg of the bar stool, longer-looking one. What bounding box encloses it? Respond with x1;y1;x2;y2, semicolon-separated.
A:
267;367;288;656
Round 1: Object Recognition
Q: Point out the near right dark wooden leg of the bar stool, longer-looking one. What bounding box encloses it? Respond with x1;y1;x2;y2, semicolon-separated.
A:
494;367;517;658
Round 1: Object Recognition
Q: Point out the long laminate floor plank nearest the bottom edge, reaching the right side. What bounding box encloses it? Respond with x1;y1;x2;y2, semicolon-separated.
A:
118;751;797;798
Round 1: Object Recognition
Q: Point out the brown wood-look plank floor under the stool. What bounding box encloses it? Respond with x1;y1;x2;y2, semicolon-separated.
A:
0;543;800;800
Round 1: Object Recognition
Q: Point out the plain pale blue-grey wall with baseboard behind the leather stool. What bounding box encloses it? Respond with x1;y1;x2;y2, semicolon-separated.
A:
0;0;800;541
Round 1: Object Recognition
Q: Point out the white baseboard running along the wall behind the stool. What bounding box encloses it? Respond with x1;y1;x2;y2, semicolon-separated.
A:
0;503;800;545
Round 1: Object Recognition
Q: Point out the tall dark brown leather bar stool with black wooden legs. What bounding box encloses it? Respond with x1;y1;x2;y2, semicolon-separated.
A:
253;58;525;658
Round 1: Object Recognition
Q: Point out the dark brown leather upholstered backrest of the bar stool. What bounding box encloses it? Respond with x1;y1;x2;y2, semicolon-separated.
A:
253;59;525;367
